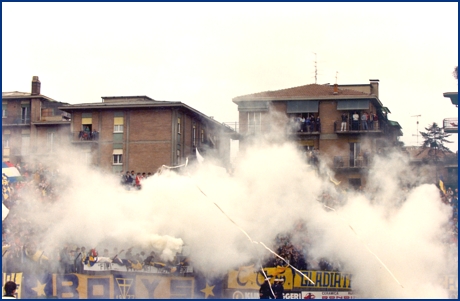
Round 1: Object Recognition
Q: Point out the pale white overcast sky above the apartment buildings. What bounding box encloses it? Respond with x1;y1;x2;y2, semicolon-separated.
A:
2;2;458;151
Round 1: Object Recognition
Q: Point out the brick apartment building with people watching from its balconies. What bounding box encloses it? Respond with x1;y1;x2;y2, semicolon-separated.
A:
233;80;402;188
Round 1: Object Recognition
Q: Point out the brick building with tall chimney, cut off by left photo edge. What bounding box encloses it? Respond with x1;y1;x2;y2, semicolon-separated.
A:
2;76;70;164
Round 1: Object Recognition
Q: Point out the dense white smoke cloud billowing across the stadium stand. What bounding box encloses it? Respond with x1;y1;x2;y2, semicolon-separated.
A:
9;134;452;298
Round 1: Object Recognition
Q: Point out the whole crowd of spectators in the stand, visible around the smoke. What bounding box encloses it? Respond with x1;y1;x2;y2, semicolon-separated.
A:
2;159;458;273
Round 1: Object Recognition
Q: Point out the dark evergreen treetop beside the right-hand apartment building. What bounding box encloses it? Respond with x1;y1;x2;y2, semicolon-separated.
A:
417;122;452;161
